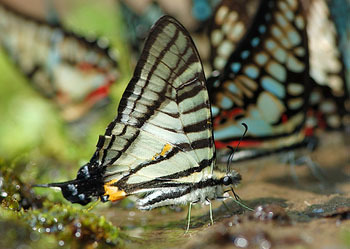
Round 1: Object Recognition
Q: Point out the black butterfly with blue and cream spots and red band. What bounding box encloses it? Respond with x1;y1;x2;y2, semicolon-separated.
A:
208;0;311;161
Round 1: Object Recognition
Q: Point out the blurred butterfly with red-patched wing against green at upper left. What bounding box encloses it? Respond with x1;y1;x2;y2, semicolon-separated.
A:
0;2;119;122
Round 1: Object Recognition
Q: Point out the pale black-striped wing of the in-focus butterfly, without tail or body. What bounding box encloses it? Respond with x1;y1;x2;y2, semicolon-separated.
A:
93;16;214;190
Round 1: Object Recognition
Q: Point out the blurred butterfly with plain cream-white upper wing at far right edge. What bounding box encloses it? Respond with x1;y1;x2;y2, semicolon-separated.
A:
304;0;350;130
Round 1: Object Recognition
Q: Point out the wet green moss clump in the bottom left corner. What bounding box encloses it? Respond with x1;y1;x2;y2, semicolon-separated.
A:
0;161;125;248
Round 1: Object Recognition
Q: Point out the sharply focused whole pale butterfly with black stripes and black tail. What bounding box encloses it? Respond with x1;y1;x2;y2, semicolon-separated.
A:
36;16;241;230
